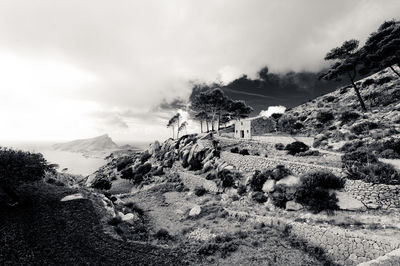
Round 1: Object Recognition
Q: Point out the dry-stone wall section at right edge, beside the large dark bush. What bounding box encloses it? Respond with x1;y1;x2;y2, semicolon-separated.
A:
344;180;400;209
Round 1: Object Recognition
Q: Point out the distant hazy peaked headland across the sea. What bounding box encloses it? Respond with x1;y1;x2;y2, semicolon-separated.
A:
53;134;118;153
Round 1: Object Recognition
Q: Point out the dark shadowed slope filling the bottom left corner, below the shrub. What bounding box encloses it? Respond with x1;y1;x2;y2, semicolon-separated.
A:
0;184;179;265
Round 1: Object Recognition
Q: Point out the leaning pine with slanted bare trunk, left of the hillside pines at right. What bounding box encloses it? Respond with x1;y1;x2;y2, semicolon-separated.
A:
319;40;367;112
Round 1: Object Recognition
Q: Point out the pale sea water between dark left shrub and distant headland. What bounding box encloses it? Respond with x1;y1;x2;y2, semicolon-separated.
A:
0;142;149;176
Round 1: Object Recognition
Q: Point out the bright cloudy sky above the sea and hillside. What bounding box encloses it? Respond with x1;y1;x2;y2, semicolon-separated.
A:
0;0;400;142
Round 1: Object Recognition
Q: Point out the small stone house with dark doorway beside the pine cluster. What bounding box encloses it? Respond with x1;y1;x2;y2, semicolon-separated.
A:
235;116;276;139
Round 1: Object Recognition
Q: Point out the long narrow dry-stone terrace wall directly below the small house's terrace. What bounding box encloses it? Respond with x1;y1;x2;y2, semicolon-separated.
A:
221;151;342;175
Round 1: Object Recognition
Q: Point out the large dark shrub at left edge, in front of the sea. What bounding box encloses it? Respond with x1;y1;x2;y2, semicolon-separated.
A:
0;147;57;184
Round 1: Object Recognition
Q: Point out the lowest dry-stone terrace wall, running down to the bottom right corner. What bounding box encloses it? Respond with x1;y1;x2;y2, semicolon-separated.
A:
227;209;400;265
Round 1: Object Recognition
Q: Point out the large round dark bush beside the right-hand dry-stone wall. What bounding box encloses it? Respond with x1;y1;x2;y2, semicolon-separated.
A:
295;171;344;213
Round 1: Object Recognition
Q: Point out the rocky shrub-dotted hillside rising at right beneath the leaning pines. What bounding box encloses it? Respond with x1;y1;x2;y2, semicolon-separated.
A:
278;69;400;158
